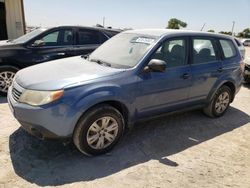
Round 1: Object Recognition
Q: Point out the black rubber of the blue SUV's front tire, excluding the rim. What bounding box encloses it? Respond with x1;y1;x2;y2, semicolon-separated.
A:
73;105;125;156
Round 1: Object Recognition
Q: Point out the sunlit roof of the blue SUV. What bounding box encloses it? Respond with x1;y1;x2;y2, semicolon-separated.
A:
125;29;232;39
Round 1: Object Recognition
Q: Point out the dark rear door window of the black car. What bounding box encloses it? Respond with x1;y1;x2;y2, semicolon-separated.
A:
78;29;100;45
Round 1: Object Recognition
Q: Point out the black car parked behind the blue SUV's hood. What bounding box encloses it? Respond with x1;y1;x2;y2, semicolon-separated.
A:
0;26;119;95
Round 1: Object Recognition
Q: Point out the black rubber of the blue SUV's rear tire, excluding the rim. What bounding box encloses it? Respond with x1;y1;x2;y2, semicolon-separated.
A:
203;86;233;118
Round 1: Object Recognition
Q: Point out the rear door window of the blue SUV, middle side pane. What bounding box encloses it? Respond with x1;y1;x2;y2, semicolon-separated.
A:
193;39;217;64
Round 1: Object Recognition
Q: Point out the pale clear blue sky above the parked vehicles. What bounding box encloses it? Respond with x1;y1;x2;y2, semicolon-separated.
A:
23;0;250;32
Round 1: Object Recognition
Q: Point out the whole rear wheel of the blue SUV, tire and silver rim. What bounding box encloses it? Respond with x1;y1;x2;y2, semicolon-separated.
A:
203;86;233;117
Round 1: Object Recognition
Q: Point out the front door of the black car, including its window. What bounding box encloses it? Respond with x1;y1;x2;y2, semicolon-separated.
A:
26;28;75;64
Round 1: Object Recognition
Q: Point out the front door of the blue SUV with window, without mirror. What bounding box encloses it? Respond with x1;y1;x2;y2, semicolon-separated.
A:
136;37;191;116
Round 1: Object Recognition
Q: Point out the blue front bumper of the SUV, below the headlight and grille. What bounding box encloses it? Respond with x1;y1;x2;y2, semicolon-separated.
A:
7;83;77;139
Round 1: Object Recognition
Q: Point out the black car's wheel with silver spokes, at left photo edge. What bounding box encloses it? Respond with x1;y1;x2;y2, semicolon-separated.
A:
0;66;18;96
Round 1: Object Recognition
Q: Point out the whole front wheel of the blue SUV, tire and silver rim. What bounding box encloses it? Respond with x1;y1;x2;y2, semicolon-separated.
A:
73;105;124;155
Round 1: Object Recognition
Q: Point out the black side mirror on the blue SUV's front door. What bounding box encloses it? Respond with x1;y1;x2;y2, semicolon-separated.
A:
144;59;167;72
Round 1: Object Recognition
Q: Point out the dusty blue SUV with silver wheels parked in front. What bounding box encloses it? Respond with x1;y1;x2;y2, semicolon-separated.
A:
8;29;244;155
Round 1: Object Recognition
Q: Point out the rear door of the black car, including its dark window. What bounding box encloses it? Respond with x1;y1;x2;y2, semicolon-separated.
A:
74;28;105;55
